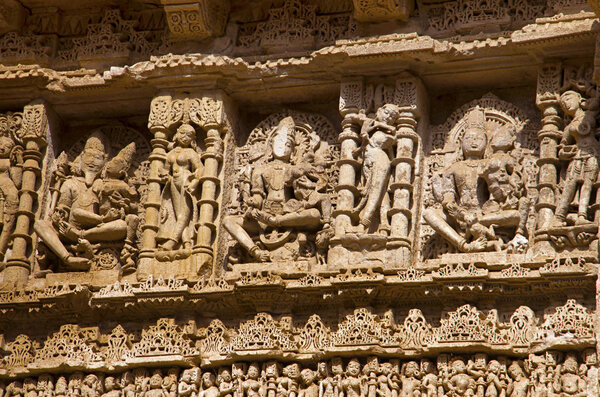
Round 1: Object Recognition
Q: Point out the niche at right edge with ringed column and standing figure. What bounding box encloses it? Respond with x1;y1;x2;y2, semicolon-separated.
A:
536;66;600;251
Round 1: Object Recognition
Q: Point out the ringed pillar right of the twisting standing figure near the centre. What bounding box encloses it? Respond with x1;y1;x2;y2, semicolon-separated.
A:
388;77;424;264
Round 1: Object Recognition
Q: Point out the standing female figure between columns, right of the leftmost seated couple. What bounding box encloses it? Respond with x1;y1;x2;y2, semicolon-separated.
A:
156;124;204;255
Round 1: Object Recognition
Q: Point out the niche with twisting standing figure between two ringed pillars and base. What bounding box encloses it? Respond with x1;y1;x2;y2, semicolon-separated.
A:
328;76;423;268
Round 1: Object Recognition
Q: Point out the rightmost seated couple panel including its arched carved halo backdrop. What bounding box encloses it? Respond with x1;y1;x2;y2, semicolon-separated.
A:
421;94;538;259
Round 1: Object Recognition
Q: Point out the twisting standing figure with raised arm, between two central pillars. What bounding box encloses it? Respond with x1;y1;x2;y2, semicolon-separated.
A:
352;104;399;234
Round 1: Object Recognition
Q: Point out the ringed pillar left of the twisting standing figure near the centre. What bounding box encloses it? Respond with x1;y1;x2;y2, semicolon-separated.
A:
334;80;364;237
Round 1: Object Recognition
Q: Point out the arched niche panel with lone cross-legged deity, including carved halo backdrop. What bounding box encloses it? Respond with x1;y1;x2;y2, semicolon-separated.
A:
224;112;339;263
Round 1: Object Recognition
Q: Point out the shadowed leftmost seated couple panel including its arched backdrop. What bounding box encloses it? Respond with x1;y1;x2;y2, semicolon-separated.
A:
34;125;149;274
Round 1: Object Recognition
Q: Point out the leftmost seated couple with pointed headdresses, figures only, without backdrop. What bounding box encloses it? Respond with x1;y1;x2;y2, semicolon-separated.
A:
34;133;139;273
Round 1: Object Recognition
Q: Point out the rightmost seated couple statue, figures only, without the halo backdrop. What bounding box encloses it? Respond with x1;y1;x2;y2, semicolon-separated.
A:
423;108;529;252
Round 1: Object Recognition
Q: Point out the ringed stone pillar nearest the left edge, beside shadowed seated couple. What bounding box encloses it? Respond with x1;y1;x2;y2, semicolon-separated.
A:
4;102;50;285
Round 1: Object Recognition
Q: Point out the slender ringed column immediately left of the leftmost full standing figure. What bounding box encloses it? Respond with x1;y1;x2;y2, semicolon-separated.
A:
140;96;171;258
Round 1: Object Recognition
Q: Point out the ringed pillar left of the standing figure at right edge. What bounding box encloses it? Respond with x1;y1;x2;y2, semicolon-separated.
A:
535;64;562;253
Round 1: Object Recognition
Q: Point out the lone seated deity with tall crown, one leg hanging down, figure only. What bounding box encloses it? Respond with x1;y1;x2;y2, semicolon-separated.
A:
224;117;331;262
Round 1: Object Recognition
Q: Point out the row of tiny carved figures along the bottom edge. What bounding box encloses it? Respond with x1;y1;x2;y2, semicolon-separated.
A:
0;349;599;397
